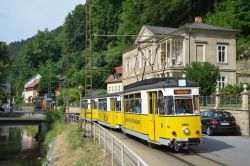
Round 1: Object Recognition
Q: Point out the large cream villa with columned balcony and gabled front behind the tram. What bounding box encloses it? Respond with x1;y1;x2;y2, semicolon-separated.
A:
123;17;237;87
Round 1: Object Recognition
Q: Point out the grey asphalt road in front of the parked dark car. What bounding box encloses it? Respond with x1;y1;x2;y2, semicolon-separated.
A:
193;136;250;166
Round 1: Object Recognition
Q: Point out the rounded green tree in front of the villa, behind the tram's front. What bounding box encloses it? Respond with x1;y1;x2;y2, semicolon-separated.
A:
184;62;220;95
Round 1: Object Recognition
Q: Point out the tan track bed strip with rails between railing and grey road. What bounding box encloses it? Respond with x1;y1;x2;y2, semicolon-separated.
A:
109;130;223;166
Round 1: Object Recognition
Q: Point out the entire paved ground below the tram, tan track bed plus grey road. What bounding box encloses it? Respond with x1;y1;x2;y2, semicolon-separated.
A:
107;131;250;166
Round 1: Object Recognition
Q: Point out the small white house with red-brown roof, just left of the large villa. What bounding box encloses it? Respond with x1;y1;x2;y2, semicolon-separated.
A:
106;66;123;93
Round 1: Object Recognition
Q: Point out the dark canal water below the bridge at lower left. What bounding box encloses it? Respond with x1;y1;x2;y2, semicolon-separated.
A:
0;126;44;166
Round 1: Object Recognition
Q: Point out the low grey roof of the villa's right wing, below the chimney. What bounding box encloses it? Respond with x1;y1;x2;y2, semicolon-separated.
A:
181;23;237;32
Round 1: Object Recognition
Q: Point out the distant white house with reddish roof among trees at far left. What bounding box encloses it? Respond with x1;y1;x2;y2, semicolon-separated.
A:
22;74;41;103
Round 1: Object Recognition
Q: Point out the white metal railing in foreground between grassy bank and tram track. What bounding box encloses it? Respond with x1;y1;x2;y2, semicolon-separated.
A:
93;123;148;166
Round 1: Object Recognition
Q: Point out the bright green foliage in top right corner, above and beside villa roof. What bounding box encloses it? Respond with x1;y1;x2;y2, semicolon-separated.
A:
205;0;250;55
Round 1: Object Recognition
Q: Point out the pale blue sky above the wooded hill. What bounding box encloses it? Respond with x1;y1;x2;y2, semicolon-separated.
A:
0;0;85;43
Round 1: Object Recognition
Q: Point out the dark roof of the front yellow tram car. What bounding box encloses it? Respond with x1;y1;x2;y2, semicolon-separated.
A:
124;77;199;93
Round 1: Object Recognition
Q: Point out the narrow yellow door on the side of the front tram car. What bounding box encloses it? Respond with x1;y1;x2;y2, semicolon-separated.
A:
148;92;157;141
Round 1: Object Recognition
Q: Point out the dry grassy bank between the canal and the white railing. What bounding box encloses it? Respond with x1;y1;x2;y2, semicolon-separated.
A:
43;121;109;166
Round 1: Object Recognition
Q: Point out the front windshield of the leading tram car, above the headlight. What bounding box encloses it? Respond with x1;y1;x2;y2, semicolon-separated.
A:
175;98;193;114
